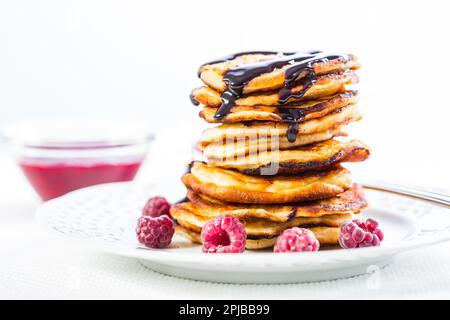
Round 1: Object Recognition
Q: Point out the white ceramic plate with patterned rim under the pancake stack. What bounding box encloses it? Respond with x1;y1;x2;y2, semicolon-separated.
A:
37;183;450;283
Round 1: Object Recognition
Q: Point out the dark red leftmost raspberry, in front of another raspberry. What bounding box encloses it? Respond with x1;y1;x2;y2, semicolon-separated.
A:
136;215;175;248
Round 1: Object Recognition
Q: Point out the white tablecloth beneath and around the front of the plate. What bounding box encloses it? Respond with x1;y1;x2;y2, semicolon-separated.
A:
0;142;450;299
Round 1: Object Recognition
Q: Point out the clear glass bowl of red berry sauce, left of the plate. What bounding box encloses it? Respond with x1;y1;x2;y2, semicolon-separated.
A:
5;119;153;201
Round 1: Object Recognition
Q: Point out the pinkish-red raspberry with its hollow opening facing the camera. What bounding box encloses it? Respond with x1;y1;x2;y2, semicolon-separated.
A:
202;215;247;253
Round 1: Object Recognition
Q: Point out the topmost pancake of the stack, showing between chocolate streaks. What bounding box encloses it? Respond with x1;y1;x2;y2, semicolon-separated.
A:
199;53;359;94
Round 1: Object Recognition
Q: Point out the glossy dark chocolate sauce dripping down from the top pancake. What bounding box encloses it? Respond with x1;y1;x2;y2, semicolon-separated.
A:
199;50;349;142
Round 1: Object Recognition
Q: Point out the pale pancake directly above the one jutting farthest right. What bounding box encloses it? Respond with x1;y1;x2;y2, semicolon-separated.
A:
198;126;347;159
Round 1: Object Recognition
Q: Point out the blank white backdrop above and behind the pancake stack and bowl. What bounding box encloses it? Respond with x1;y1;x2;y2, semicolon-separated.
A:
0;0;450;187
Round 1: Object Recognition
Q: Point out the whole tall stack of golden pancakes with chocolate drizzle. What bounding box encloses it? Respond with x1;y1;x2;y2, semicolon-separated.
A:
171;51;370;249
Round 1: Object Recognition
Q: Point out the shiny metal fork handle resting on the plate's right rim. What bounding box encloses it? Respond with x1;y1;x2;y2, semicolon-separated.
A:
361;182;450;209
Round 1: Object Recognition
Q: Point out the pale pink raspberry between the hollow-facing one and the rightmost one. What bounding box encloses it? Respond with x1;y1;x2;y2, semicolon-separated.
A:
273;227;320;253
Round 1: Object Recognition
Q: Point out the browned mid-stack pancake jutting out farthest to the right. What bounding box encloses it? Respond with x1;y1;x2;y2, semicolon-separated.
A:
204;140;370;175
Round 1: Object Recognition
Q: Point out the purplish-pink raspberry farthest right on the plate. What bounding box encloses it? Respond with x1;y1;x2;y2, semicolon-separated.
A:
339;218;384;249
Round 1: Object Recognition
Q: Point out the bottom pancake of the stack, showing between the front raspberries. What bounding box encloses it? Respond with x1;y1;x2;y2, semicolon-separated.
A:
175;225;340;250
